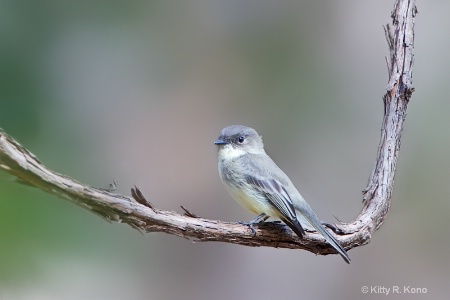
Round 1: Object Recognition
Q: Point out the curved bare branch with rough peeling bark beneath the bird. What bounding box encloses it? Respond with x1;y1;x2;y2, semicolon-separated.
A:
0;0;417;255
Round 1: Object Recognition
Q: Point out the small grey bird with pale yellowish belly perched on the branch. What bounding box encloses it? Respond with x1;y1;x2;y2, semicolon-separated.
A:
214;125;350;263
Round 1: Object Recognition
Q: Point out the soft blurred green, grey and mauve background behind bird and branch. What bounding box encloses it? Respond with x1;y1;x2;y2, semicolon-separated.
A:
0;0;450;300
